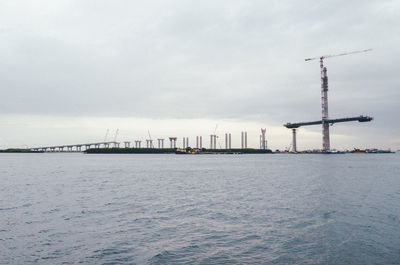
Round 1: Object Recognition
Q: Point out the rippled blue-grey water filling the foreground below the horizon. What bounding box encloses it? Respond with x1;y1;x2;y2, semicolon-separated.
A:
0;154;400;264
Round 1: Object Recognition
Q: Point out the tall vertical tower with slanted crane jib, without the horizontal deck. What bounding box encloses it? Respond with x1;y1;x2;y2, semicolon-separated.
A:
305;49;372;151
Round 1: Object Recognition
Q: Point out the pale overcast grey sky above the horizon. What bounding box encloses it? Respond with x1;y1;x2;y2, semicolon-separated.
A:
0;0;400;150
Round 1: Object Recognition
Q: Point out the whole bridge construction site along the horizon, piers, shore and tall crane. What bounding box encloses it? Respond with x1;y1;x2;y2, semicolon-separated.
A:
0;49;391;154
